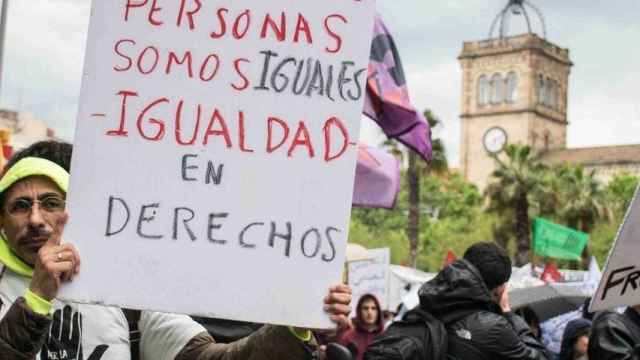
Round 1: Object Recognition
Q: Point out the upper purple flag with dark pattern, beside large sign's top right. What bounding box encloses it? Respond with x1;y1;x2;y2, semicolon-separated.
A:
364;15;431;162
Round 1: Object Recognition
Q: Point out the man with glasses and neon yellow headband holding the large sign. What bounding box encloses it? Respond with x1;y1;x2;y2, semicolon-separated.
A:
0;141;351;360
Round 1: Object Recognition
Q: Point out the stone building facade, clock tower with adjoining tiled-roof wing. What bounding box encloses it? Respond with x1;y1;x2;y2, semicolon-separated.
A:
458;33;640;190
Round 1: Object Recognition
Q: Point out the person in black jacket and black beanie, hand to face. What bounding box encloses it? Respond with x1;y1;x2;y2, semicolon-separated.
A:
419;242;552;360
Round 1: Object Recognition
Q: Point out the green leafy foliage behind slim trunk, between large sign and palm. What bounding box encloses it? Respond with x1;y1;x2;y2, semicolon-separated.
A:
350;172;480;271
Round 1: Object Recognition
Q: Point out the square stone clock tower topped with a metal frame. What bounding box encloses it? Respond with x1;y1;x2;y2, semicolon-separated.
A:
458;0;573;191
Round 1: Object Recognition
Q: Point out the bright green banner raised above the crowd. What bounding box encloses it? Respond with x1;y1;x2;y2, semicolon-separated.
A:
533;218;589;260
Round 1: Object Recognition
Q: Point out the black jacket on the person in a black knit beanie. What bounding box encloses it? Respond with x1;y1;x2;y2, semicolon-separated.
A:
419;260;552;360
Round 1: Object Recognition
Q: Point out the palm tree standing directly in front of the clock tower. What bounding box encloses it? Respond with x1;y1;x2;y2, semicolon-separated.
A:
486;144;546;266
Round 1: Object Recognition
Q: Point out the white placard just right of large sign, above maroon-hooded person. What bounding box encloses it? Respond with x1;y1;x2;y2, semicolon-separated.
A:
348;248;391;310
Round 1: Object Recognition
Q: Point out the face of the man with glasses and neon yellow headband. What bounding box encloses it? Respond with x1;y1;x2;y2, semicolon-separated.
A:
0;176;66;266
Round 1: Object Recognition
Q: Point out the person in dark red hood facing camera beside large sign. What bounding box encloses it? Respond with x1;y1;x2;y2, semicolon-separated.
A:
339;294;384;360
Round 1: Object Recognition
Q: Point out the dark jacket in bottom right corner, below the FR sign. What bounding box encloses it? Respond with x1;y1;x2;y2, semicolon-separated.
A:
589;308;640;360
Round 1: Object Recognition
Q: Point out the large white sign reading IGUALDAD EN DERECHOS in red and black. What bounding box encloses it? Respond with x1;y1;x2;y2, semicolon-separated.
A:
63;0;375;327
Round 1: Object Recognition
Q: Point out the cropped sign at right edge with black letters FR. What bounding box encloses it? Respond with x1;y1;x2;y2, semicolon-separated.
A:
589;186;640;312
